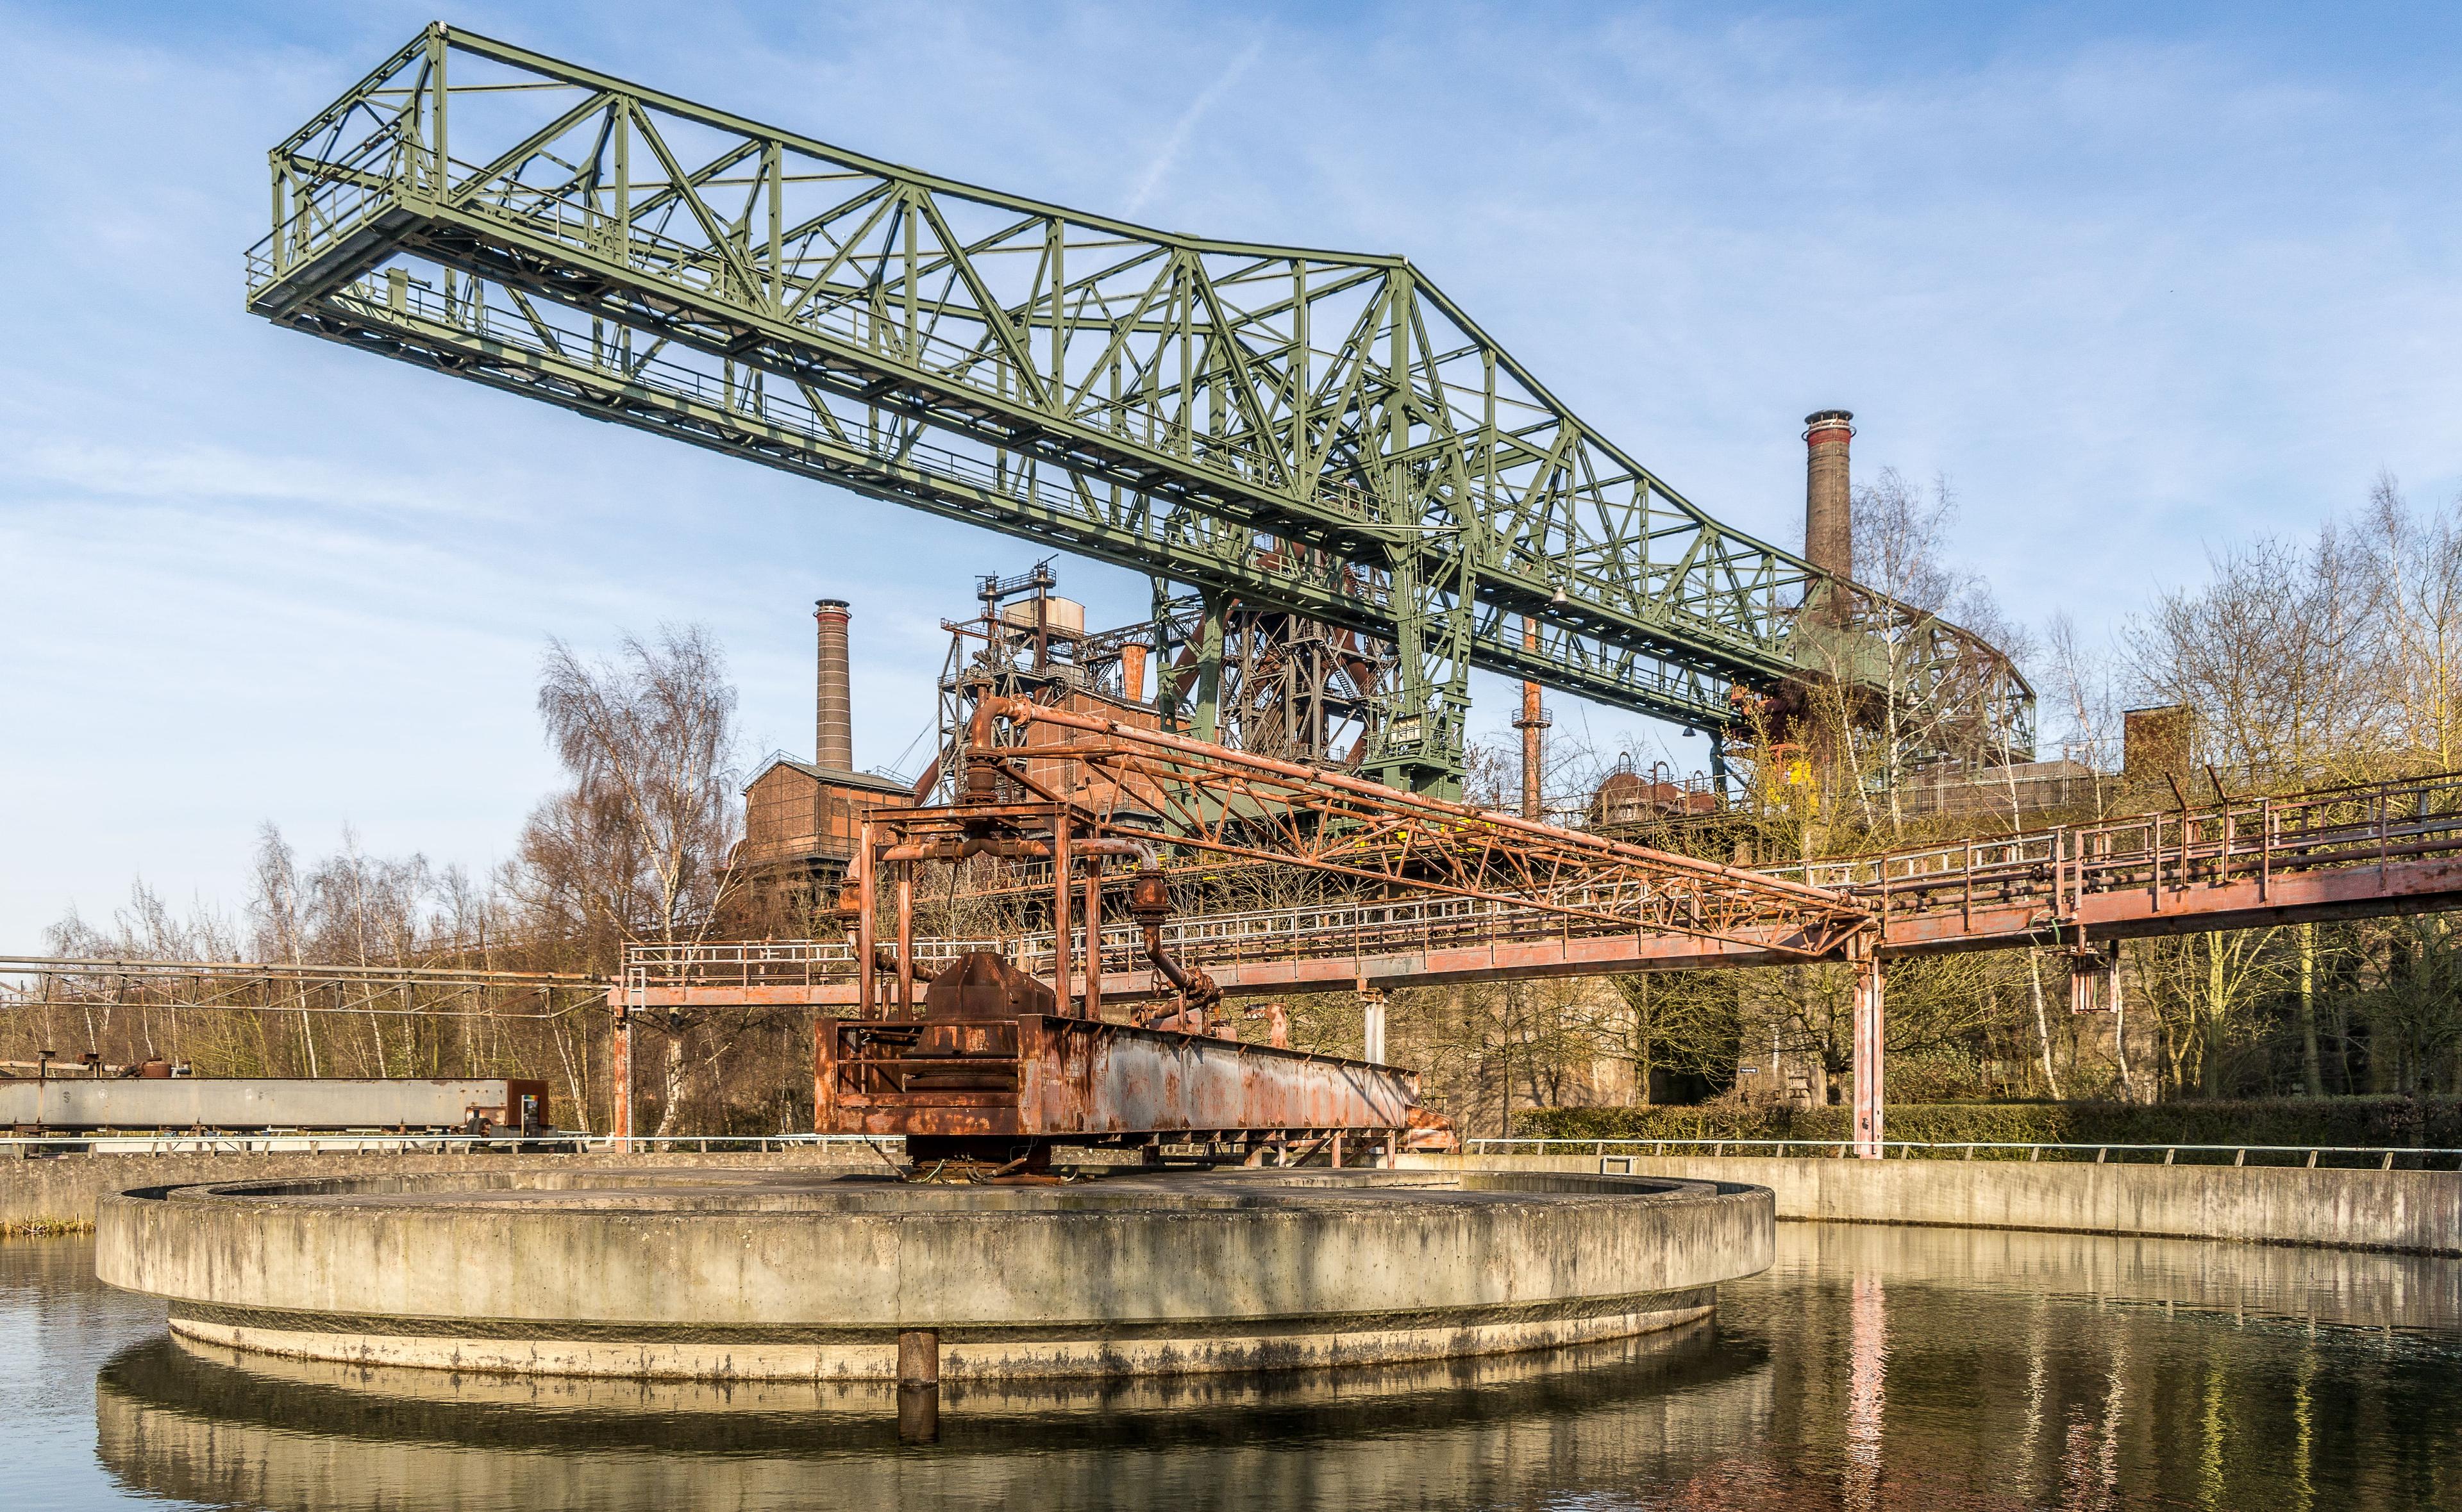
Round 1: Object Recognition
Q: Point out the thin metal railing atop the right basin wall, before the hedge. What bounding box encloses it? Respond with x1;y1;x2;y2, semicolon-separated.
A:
1462;1138;2462;1170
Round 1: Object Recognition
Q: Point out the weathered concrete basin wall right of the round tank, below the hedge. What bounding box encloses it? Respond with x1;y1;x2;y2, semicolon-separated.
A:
1403;1155;2462;1256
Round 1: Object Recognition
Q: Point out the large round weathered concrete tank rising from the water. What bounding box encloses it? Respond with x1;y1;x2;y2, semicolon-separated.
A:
96;1170;1773;1381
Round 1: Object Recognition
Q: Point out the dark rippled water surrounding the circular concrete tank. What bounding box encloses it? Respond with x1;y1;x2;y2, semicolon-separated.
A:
0;1224;2462;1512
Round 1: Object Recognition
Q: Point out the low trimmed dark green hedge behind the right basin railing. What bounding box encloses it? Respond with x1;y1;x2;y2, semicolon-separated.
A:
1512;1096;2462;1150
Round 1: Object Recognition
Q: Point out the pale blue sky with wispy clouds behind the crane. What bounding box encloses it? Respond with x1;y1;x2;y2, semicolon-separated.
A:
0;3;2462;948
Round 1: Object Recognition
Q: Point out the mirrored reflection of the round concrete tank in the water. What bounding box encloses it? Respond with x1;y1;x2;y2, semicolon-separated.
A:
96;1325;1770;1509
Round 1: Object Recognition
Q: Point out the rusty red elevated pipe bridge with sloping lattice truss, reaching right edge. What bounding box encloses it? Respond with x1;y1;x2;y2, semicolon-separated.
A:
610;733;2462;1155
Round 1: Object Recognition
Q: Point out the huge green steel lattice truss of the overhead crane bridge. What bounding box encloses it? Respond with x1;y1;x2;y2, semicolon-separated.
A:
249;24;2034;788
